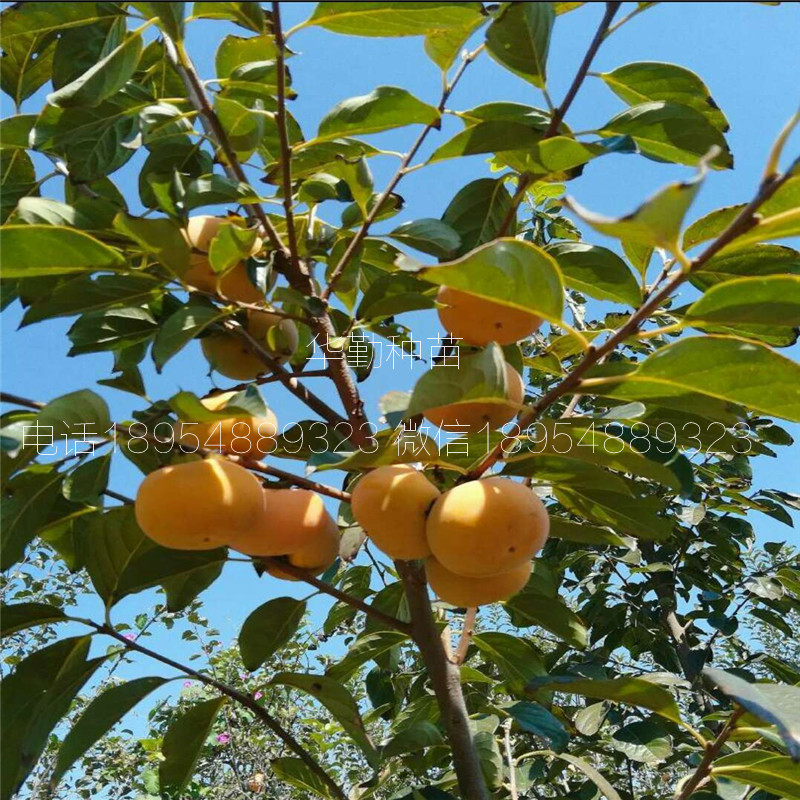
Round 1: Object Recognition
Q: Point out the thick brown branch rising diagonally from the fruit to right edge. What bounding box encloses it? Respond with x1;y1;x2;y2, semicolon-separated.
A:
467;170;792;480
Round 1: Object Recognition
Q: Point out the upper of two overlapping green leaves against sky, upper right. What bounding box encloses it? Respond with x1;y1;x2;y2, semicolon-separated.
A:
597;61;729;133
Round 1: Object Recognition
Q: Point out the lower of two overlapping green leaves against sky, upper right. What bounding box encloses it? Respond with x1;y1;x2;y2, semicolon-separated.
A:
598;102;733;169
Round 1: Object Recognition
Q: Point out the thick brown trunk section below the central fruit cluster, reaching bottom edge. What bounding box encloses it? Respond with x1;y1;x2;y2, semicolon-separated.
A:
395;561;489;800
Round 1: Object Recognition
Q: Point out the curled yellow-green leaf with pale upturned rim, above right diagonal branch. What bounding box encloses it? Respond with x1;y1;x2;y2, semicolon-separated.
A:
567;170;705;252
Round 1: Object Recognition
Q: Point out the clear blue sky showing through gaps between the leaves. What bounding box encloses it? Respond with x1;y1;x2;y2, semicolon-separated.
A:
2;2;800;664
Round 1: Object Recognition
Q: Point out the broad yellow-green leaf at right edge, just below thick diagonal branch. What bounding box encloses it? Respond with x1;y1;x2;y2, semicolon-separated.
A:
583;336;800;422
